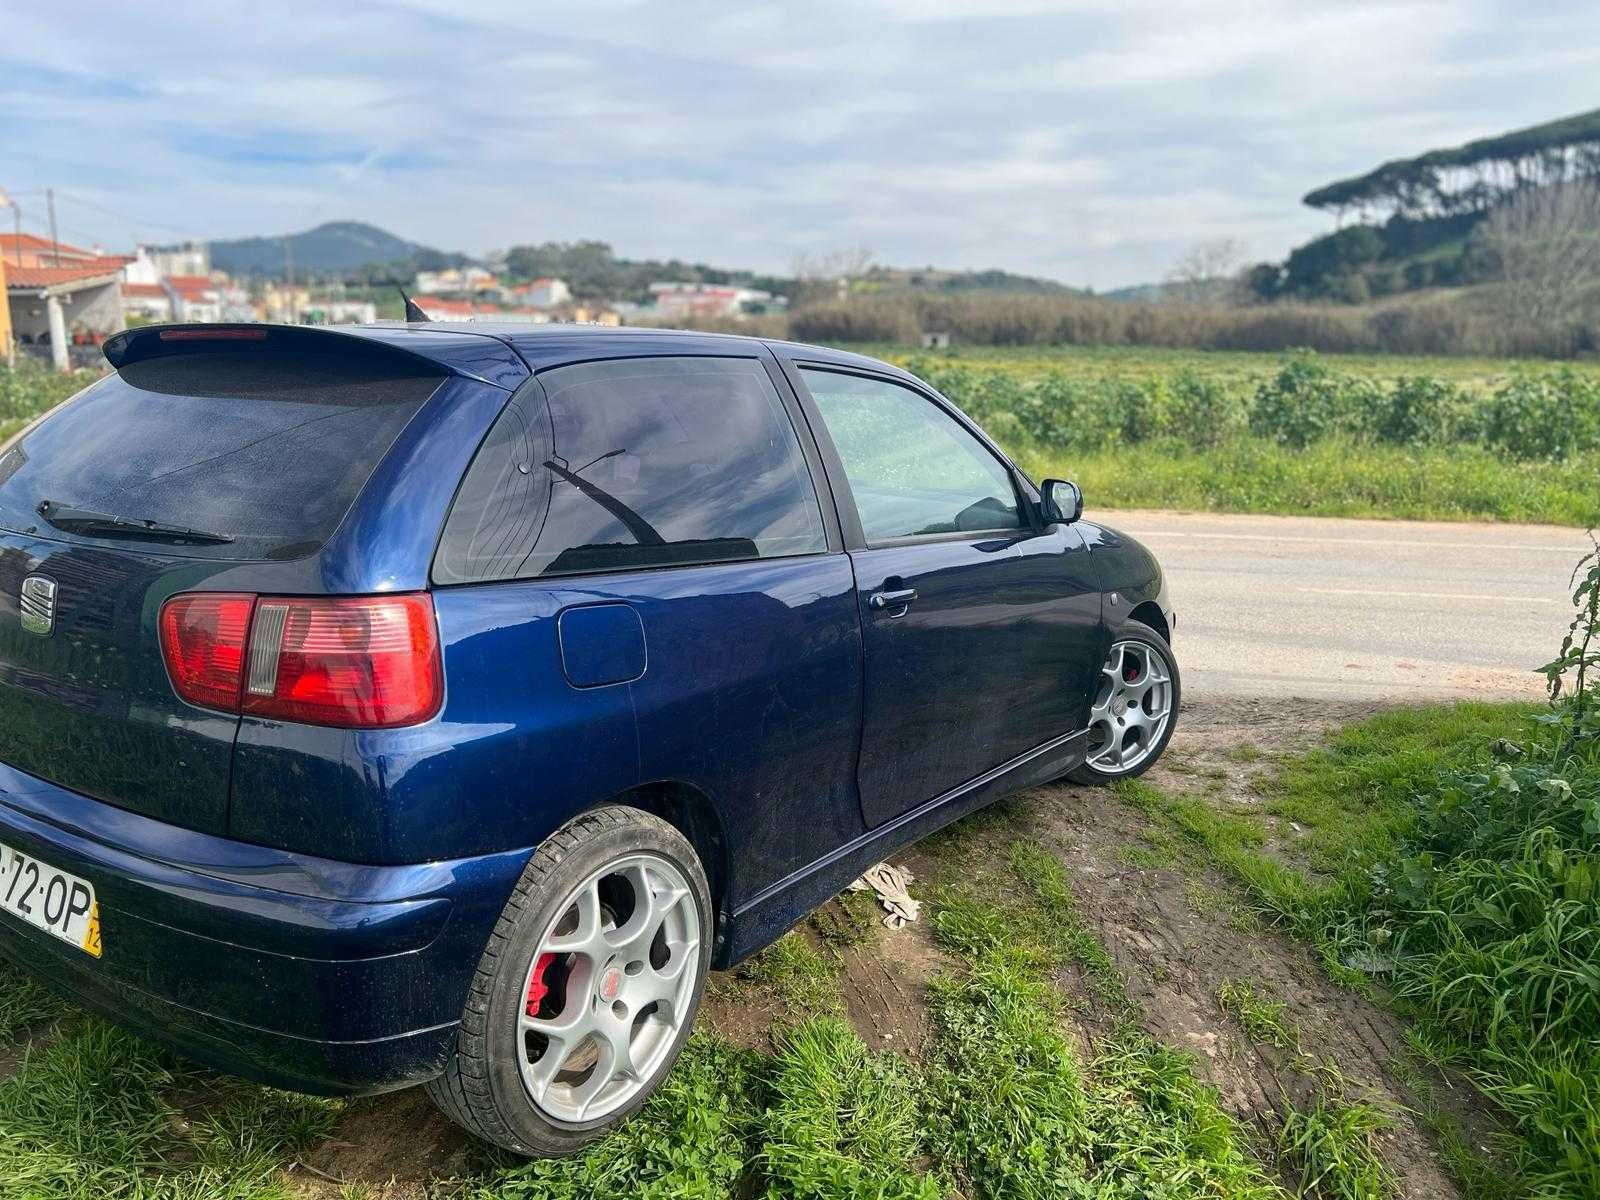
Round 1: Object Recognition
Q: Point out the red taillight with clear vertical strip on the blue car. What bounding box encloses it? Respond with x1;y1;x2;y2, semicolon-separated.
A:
162;594;443;730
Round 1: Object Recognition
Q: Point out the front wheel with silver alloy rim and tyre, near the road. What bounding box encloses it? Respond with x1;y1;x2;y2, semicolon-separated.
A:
1067;621;1182;784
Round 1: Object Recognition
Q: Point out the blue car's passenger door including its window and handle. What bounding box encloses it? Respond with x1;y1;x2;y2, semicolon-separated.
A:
795;365;1102;827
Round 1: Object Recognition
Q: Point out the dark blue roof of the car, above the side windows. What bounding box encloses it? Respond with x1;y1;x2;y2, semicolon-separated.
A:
344;322;912;379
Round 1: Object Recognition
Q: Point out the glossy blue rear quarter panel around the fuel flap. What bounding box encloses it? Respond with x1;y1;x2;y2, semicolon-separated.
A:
234;554;862;898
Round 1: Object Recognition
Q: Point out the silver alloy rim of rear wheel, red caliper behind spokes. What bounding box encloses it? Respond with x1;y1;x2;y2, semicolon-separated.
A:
518;853;701;1125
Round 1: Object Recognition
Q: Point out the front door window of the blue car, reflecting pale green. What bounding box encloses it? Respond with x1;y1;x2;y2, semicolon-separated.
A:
802;368;1022;542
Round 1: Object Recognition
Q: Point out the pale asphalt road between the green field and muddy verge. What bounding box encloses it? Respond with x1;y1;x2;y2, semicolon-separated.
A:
1090;510;1589;701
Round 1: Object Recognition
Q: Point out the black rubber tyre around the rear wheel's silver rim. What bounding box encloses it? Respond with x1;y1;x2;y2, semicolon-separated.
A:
426;808;715;1158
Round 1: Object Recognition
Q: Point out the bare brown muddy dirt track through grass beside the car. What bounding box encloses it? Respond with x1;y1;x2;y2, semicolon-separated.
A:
1021;701;1458;1200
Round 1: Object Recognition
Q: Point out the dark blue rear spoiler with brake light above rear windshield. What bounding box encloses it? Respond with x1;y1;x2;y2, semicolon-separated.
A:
101;323;530;389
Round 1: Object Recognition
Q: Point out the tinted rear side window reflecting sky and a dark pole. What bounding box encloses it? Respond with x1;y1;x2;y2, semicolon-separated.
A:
434;358;827;584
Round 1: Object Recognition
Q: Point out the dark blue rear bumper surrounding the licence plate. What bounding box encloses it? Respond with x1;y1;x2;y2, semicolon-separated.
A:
0;765;531;1094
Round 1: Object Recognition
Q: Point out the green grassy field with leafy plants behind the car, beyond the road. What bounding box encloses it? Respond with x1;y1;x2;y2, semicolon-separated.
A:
0;347;1600;526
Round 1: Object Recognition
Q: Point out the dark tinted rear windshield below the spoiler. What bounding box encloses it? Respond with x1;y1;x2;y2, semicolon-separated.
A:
0;352;440;558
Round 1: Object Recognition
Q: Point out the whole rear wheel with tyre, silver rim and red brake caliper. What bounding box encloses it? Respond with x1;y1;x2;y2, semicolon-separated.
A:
427;808;712;1157
